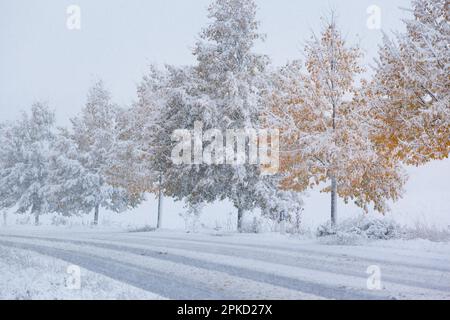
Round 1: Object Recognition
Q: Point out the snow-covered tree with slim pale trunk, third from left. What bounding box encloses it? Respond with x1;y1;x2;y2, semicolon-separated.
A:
113;66;190;228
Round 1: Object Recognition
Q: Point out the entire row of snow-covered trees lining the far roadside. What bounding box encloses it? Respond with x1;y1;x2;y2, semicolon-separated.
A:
0;0;450;230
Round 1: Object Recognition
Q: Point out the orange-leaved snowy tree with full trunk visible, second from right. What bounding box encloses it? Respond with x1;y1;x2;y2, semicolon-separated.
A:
267;17;405;225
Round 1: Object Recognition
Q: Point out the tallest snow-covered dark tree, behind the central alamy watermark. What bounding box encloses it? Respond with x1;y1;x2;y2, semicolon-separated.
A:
157;0;298;230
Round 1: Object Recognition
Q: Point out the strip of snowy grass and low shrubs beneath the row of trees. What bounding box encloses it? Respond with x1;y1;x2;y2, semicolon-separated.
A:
6;214;450;246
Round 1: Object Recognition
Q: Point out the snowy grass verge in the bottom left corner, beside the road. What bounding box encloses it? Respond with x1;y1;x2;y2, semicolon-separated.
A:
0;246;163;300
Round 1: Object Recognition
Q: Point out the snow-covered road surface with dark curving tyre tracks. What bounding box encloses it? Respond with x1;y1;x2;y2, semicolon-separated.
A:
0;228;450;299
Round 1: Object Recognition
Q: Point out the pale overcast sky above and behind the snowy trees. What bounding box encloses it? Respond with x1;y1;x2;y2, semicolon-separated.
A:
0;0;450;224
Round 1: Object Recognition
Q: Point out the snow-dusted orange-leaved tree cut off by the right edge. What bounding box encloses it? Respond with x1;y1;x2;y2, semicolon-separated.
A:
367;0;450;165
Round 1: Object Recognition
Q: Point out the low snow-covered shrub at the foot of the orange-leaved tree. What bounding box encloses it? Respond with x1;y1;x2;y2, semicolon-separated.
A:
316;216;403;244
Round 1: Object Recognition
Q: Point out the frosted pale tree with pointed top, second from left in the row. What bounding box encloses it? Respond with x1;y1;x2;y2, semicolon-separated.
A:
51;81;141;225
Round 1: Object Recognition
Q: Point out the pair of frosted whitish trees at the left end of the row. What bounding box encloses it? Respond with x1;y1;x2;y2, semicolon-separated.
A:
0;83;142;224
